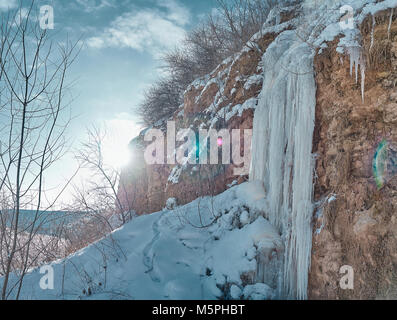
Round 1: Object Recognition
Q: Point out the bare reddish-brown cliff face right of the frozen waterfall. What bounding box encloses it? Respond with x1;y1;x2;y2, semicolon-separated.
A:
309;10;397;299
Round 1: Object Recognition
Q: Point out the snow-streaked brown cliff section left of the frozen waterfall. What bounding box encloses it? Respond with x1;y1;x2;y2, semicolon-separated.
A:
119;33;282;214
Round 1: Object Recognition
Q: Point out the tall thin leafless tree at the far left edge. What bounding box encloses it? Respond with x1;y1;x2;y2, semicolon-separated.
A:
0;1;76;299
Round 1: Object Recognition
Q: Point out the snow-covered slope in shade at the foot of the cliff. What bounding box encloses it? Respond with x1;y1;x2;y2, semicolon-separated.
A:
0;182;283;299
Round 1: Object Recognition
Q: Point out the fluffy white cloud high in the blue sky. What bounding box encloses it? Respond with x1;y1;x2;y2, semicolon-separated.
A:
87;0;190;57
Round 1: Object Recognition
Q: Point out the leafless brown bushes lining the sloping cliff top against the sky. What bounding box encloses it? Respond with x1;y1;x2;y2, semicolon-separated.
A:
138;0;278;126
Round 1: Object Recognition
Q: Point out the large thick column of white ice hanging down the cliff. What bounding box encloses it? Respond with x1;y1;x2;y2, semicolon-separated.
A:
250;31;316;299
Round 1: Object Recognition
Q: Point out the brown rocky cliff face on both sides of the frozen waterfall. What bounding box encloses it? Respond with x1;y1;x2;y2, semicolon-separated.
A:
119;2;397;299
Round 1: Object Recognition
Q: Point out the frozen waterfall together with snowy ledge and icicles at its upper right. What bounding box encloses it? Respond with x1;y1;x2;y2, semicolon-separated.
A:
250;0;397;298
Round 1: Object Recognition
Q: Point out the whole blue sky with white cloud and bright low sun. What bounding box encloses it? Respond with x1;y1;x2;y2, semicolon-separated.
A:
0;0;216;208
